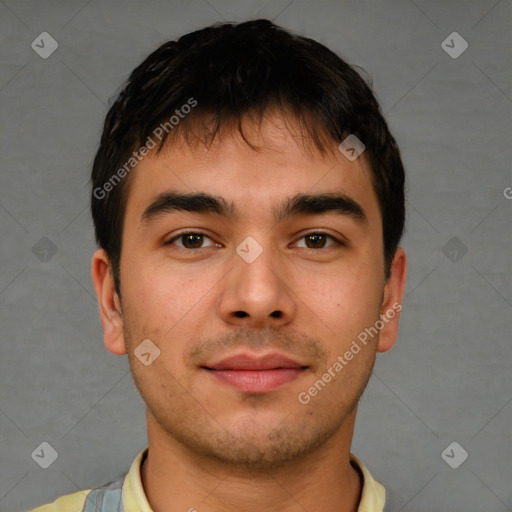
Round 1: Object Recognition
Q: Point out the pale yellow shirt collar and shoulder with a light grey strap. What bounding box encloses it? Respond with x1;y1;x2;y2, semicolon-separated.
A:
29;448;386;512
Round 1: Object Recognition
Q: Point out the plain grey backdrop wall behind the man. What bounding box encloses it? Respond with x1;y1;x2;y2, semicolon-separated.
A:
0;0;512;512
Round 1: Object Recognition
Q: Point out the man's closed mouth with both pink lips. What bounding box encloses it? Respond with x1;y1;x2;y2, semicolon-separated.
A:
201;352;309;394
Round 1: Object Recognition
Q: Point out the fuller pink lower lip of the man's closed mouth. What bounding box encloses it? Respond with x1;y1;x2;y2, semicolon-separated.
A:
207;368;305;393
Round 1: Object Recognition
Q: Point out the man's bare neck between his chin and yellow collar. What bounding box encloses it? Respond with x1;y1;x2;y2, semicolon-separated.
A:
141;410;362;512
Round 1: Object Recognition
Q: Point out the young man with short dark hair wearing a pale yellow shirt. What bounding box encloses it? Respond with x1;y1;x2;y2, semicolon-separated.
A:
31;20;406;512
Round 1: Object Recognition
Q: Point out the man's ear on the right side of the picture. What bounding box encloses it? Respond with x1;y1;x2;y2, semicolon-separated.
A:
377;247;407;352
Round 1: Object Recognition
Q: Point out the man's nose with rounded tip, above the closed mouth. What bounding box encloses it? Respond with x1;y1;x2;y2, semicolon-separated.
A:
219;238;297;329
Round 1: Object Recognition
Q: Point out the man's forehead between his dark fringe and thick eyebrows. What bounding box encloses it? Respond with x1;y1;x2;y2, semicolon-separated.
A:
126;115;379;229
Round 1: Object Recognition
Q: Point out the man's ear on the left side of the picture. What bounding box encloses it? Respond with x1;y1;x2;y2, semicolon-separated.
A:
91;249;126;356
